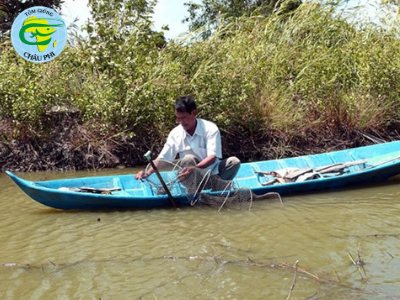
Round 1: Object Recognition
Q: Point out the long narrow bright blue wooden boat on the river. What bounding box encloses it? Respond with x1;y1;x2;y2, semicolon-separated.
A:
7;141;400;210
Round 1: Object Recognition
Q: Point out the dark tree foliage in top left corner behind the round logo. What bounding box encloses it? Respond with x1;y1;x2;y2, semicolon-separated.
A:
0;0;64;41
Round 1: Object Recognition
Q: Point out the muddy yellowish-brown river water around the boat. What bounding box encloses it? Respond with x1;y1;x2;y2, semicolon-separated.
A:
0;169;400;300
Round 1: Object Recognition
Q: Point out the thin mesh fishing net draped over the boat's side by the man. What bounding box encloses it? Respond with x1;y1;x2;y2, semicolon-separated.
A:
142;159;283;211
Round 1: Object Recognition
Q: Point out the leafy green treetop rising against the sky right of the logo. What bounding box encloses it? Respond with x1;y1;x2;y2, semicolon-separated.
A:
84;0;166;76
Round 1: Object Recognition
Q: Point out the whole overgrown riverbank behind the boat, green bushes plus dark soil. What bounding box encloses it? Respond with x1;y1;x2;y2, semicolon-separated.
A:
0;2;400;171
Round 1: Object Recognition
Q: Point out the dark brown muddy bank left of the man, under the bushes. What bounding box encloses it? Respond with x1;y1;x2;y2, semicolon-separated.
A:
0;114;161;172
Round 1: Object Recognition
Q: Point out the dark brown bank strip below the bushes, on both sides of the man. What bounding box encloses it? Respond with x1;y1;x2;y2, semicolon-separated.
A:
0;114;400;172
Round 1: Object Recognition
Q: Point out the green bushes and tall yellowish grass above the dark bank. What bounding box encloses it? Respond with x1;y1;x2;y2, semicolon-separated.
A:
0;0;400;169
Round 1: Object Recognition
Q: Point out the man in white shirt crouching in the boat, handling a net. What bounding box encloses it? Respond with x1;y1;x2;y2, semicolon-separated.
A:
135;96;240;180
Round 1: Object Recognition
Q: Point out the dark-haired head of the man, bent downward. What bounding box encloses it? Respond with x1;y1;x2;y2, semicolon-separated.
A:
174;96;197;135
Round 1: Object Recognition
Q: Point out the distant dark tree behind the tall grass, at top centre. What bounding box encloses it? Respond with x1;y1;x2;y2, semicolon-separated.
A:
182;0;302;38
